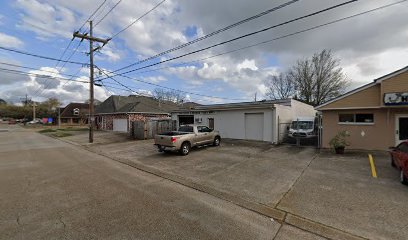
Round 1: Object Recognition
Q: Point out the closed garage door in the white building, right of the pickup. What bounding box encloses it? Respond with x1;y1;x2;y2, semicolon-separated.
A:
245;113;264;141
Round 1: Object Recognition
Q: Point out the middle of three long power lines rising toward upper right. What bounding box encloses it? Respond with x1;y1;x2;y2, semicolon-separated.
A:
97;0;359;79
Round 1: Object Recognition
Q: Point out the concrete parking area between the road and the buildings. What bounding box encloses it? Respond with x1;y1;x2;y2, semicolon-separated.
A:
59;133;408;239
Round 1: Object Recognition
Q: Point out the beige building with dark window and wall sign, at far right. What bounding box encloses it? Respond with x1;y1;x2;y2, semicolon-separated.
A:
316;67;408;150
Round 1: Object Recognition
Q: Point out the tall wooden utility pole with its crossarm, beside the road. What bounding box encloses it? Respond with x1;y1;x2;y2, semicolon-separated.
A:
73;21;110;143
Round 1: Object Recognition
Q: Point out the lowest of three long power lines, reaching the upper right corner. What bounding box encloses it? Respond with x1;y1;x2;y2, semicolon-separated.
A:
125;0;408;77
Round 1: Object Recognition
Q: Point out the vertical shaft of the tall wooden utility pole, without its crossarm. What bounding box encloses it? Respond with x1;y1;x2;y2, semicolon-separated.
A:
89;21;94;143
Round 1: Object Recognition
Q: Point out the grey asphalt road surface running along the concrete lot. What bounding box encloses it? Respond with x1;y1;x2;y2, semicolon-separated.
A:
0;124;280;239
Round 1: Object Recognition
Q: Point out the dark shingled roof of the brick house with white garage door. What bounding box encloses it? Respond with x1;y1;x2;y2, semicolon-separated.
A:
95;95;179;114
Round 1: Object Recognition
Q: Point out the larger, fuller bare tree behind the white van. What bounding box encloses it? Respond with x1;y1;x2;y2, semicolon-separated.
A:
288;50;349;106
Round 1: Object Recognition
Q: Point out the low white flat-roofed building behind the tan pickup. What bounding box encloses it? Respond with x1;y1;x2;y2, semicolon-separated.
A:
171;99;316;143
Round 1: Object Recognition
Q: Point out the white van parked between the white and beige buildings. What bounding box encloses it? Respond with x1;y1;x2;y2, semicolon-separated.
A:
289;117;317;138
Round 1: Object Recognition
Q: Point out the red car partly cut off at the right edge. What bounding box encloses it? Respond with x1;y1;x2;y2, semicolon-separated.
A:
390;140;408;185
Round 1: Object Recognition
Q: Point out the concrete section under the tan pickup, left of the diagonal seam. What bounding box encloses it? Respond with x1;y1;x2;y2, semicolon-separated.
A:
92;140;316;207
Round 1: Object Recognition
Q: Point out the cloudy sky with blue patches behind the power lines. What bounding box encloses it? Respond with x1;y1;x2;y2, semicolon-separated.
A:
0;0;408;103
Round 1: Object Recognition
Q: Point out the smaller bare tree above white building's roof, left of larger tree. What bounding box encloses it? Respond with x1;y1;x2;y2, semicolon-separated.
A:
265;72;295;99
